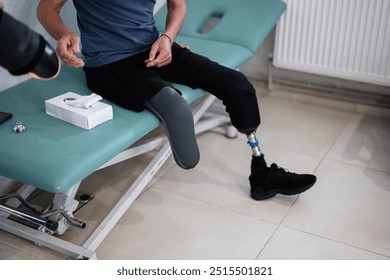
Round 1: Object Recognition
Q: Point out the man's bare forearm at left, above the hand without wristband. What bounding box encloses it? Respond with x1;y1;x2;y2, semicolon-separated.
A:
37;0;72;41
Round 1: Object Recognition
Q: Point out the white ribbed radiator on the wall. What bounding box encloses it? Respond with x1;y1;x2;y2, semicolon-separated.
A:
274;0;390;86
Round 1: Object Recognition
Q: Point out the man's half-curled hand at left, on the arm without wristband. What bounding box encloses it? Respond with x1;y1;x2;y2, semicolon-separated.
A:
56;32;84;68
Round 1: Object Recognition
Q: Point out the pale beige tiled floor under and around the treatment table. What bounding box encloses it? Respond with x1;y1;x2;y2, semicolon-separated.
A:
0;83;390;260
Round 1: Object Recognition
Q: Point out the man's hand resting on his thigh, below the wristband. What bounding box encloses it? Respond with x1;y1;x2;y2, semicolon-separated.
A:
145;35;172;68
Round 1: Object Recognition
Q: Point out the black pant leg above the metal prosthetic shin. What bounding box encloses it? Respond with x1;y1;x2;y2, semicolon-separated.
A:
158;44;260;133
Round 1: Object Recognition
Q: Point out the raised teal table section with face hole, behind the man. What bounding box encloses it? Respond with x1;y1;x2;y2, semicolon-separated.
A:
156;0;286;55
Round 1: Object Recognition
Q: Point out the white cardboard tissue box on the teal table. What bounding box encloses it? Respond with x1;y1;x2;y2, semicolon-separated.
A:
45;91;113;129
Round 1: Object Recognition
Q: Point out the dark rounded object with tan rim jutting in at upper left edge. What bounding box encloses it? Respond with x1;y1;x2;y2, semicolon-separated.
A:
0;9;60;80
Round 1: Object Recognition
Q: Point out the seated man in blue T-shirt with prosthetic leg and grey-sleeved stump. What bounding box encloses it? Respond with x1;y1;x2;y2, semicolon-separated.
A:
37;0;316;200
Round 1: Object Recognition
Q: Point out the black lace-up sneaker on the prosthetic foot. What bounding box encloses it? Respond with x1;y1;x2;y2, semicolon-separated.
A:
249;156;317;200
